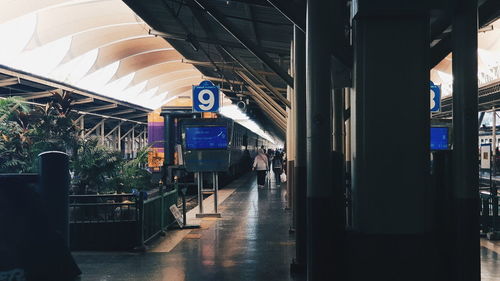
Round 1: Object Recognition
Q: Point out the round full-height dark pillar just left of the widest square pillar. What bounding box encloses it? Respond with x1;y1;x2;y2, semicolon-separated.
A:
304;0;337;281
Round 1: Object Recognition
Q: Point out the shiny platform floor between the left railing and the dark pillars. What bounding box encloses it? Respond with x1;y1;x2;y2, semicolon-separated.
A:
73;174;302;281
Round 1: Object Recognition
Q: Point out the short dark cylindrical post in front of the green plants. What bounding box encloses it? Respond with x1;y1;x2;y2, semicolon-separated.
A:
37;151;70;247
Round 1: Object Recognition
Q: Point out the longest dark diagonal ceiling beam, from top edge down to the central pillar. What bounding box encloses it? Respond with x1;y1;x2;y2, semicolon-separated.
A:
193;0;293;88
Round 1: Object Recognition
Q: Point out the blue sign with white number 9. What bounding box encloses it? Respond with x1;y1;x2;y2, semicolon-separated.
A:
193;80;220;112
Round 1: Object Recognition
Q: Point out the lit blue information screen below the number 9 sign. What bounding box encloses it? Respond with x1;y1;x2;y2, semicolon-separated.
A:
186;126;228;150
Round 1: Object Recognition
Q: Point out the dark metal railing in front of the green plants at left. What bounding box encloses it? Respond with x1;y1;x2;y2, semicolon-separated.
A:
69;185;178;249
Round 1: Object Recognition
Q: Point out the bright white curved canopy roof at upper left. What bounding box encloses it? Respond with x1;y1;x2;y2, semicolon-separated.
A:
0;0;202;109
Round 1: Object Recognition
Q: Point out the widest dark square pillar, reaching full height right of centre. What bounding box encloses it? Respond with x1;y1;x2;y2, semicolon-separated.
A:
348;0;430;281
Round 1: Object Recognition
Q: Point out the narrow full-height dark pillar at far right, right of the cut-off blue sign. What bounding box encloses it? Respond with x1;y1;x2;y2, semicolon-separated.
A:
452;0;481;281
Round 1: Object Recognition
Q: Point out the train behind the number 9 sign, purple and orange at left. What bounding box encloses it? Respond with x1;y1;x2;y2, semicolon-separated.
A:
148;104;271;185
